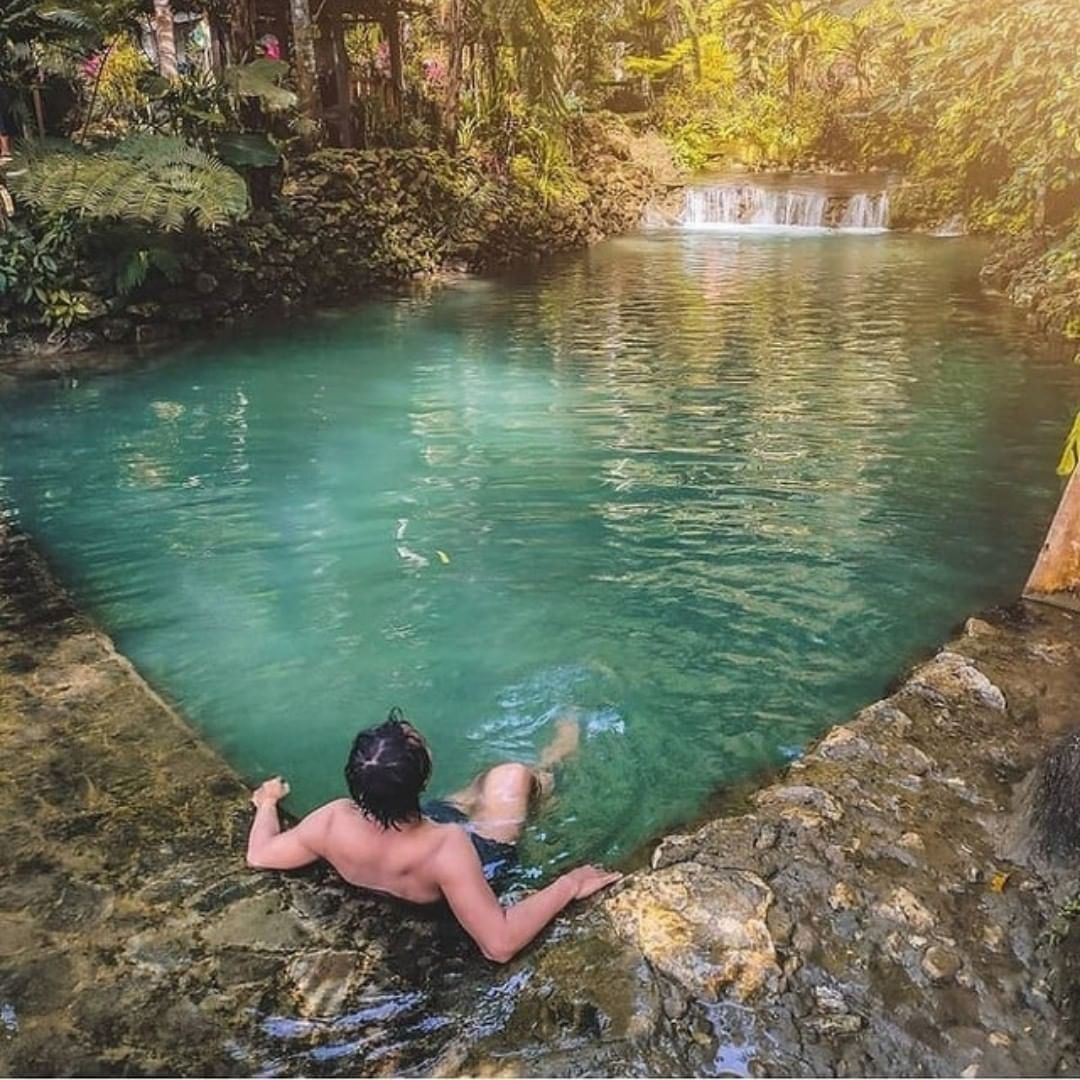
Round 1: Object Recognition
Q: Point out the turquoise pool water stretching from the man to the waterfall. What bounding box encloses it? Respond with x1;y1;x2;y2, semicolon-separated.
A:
0;230;1080;872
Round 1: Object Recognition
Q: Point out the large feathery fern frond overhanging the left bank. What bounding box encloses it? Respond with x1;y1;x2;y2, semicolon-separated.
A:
11;135;247;232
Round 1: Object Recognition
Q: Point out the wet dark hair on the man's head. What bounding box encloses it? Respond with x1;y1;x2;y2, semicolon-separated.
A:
345;707;431;828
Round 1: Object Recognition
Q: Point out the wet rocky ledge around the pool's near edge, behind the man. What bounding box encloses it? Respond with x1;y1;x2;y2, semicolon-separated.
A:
0;518;1080;1077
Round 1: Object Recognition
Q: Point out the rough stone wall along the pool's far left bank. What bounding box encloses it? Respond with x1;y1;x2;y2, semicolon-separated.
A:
0;117;677;362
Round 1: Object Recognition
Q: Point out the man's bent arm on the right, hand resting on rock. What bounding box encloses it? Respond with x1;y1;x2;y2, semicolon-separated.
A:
436;829;622;963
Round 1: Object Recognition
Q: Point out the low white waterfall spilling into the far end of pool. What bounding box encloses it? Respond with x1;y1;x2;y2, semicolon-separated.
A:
678;184;889;230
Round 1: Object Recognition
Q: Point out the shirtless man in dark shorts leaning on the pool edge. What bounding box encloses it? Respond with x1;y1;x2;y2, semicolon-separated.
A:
247;708;622;963
